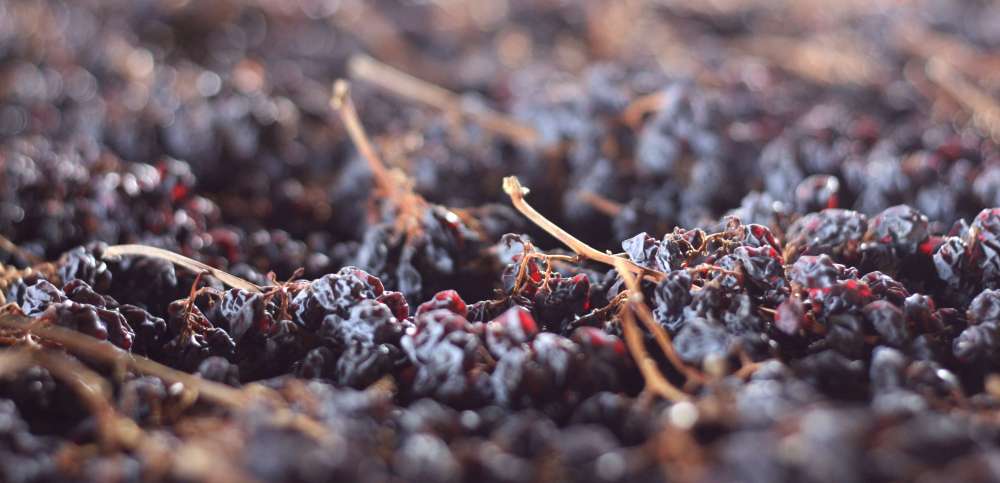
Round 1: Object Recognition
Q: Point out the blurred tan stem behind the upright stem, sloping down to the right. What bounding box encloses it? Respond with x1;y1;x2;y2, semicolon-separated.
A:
348;55;539;147
